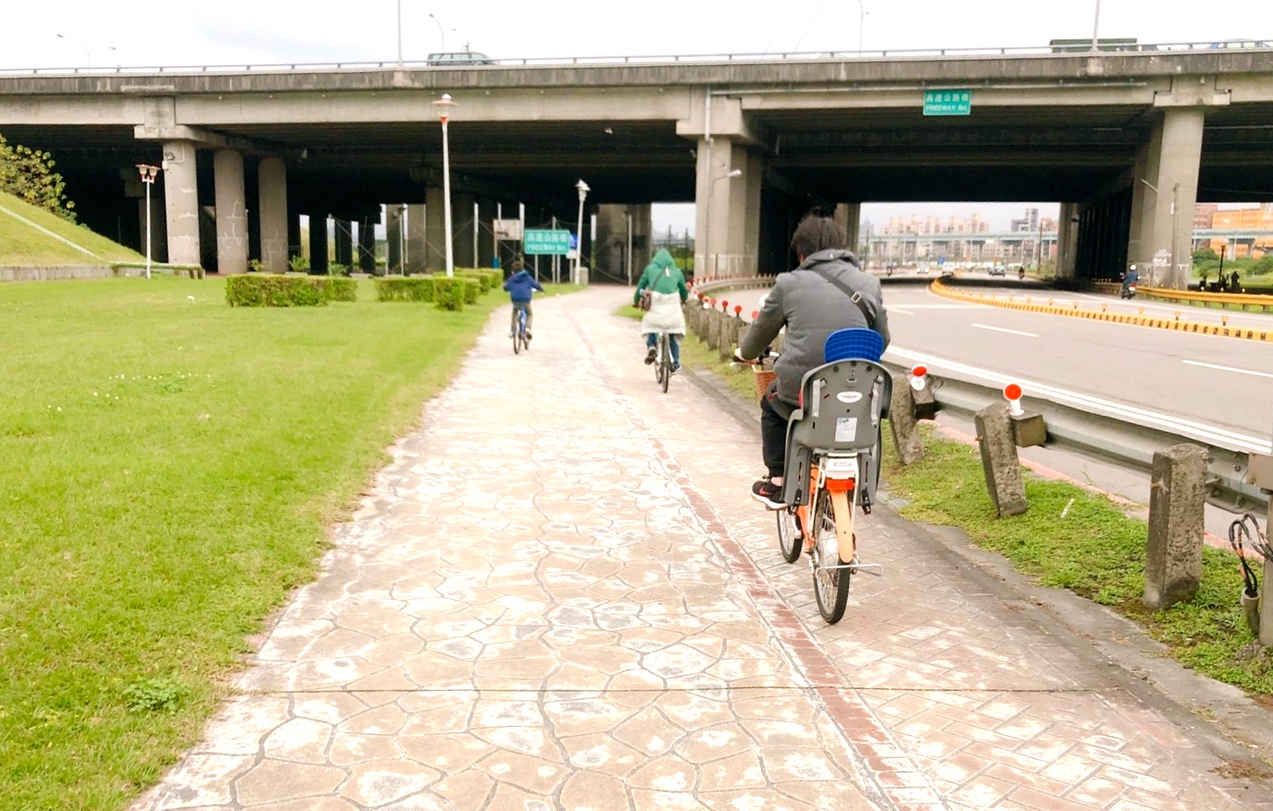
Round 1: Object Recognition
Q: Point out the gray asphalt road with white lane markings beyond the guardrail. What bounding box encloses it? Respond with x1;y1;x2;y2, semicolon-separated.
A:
728;278;1273;451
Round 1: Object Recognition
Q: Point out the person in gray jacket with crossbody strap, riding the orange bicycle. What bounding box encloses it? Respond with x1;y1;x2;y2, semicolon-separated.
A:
735;214;890;509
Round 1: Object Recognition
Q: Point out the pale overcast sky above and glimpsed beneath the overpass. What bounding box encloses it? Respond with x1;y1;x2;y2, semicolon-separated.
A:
7;0;1273;229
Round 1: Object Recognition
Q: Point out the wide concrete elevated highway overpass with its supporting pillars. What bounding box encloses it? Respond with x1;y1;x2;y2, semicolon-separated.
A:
0;47;1273;278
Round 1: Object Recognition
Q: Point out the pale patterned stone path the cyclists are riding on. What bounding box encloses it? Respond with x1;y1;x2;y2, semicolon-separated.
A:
134;288;1273;811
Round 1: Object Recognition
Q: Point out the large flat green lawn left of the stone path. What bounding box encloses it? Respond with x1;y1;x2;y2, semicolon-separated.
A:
0;276;507;810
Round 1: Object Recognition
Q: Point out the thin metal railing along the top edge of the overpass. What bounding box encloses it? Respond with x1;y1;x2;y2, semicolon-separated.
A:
0;39;1273;76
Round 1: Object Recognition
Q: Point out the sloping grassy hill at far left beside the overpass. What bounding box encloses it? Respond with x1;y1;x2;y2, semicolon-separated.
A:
0;192;145;267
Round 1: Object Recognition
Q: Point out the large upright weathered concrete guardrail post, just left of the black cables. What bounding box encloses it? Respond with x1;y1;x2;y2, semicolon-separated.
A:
1143;443;1207;610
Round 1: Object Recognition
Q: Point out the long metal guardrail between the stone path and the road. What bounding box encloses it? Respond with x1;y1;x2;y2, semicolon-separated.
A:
694;278;1269;512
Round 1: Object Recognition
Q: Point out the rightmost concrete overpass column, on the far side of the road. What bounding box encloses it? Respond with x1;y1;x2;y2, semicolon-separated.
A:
1128;107;1207;289
